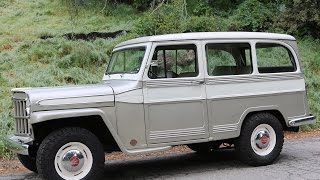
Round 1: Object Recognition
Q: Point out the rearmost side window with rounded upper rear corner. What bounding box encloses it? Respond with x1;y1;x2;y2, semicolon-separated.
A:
256;43;296;73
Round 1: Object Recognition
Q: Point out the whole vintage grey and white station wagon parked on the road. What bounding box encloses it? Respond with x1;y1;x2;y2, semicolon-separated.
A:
8;32;315;179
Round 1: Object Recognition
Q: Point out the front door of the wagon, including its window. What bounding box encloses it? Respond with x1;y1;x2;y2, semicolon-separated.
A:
143;41;209;145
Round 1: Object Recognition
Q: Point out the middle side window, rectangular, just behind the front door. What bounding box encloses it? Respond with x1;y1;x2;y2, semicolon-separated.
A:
206;43;252;76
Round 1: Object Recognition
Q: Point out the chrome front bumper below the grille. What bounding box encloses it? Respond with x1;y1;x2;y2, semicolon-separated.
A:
5;135;33;155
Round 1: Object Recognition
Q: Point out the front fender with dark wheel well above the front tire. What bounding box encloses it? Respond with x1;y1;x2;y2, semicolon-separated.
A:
31;108;126;151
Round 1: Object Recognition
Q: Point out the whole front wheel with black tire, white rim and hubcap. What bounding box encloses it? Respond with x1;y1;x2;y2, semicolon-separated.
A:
37;128;104;180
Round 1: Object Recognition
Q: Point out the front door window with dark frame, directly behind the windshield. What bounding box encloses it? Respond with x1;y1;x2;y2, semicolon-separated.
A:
148;44;198;79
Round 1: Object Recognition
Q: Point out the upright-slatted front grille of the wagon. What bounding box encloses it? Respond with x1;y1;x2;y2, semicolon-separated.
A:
13;99;30;135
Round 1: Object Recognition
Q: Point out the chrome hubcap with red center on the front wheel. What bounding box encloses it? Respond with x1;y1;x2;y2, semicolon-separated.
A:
61;150;84;172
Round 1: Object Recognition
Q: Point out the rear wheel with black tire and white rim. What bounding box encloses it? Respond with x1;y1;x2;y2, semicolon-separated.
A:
235;113;283;166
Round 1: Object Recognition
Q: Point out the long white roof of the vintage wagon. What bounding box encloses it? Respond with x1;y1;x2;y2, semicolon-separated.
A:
116;32;296;47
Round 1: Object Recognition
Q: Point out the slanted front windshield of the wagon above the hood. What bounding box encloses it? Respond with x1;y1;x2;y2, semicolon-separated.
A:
106;47;146;74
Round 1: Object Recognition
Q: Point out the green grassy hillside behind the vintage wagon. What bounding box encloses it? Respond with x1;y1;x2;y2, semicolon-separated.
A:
0;0;320;157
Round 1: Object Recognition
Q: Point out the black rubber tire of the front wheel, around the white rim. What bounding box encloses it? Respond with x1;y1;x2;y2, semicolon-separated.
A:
36;127;105;180
